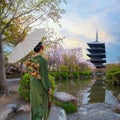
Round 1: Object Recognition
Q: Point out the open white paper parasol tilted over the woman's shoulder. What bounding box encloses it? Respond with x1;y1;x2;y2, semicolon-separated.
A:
8;28;45;63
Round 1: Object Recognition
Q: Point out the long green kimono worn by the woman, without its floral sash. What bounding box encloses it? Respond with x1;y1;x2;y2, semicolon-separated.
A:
30;55;50;120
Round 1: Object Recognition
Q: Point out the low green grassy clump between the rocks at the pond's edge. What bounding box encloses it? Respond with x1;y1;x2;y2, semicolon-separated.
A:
54;99;77;114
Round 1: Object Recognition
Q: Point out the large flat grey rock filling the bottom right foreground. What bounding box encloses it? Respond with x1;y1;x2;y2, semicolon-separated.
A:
67;103;120;120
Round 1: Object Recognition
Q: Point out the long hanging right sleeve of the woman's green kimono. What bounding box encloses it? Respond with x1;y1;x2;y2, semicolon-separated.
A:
39;58;50;91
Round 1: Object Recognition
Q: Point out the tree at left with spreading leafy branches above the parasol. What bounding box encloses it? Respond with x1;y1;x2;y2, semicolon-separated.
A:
0;0;64;94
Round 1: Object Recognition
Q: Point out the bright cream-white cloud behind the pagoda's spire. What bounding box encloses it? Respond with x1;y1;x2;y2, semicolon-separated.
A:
62;14;114;43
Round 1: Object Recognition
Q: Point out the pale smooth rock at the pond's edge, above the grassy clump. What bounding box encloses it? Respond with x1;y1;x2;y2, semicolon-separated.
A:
54;92;77;104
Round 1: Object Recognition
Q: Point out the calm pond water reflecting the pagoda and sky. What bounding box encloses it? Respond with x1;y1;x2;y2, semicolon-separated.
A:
58;80;120;105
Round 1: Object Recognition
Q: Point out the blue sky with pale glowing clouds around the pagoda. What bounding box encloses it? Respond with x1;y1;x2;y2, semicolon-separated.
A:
48;0;120;63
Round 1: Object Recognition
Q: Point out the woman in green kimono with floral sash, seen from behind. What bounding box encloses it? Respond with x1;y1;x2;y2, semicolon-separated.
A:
28;42;51;120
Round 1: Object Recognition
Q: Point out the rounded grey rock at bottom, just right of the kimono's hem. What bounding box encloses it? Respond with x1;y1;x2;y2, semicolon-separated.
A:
48;106;66;120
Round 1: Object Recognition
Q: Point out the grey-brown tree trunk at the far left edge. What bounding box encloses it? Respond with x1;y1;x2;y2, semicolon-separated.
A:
0;38;8;94
